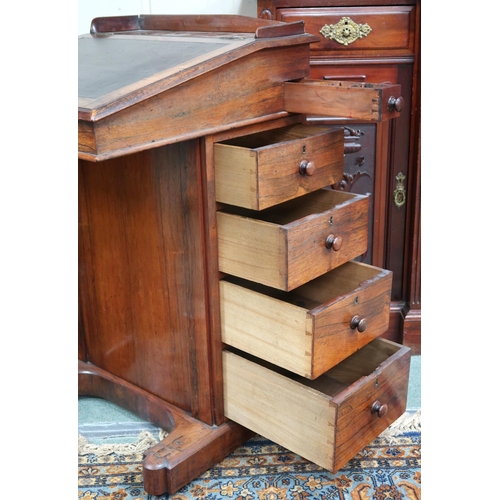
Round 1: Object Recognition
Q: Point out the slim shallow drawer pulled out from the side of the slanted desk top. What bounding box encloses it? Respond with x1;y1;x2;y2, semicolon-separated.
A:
284;79;403;122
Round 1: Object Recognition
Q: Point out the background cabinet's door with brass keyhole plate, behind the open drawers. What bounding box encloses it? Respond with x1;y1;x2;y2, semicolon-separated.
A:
309;60;413;308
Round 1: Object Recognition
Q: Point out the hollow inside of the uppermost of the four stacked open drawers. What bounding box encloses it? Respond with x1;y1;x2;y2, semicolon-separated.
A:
220;125;335;149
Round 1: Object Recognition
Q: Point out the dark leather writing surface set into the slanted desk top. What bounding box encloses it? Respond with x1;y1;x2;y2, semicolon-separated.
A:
78;37;228;98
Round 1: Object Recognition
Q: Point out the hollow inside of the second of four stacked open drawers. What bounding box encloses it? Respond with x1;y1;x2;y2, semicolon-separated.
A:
219;189;365;225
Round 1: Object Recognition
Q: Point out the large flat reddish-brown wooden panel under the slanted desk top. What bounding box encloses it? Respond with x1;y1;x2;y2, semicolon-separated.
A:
79;141;212;424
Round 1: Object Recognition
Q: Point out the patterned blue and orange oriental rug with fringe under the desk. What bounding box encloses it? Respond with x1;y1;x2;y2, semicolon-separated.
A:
78;412;421;500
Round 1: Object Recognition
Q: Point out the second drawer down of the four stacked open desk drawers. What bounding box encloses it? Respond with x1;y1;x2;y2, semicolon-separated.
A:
217;189;368;291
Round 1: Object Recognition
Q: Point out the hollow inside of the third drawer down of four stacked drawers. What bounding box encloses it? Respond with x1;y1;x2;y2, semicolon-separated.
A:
224;261;383;310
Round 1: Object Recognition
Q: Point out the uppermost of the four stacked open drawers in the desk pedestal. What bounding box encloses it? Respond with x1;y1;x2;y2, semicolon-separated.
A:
214;125;344;210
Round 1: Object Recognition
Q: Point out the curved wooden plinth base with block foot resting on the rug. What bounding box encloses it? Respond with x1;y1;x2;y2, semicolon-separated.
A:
78;360;254;495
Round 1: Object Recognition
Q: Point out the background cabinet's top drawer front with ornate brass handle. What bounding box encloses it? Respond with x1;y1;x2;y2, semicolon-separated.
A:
278;6;415;57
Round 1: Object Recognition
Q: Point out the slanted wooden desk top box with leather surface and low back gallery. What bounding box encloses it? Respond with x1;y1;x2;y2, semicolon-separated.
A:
78;16;317;161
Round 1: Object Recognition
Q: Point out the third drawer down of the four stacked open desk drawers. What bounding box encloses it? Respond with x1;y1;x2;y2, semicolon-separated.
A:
219;262;392;379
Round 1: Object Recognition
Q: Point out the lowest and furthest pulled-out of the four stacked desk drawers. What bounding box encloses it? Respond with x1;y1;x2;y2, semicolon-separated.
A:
222;339;410;472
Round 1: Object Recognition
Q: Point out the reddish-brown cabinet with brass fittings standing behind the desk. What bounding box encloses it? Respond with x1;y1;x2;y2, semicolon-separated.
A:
257;0;421;354
